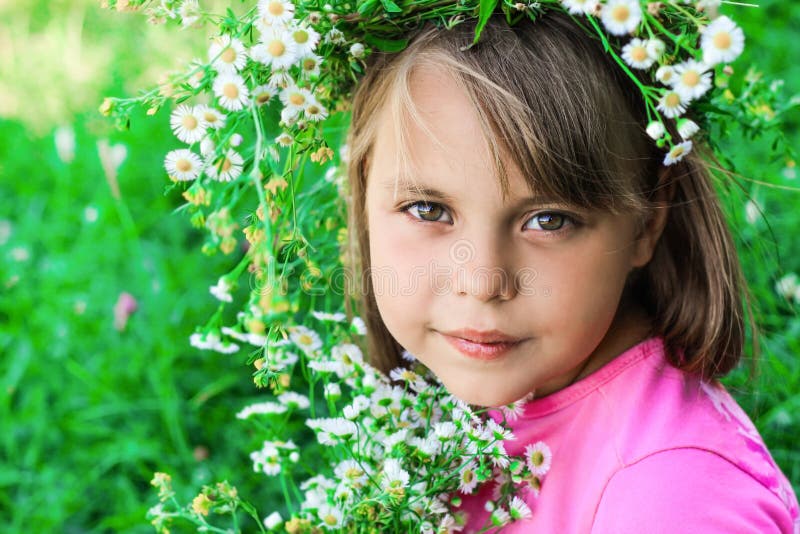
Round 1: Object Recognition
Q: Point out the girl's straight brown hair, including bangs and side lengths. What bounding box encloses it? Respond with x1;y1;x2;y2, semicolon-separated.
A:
338;13;758;384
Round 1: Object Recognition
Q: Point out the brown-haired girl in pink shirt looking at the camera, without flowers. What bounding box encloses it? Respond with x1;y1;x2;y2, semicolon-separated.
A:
340;9;800;533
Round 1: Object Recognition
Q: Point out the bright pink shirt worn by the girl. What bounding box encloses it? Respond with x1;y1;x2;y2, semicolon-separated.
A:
462;337;800;534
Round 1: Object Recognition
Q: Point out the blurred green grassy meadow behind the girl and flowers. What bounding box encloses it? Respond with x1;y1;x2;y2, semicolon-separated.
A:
0;0;800;533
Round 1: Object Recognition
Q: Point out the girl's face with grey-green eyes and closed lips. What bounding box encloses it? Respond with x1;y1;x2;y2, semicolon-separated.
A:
366;65;660;406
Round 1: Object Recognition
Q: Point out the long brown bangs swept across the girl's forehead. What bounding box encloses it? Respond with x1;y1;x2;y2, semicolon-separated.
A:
383;15;658;213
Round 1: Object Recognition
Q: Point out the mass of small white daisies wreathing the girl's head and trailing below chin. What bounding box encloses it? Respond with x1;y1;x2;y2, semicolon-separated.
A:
100;0;796;532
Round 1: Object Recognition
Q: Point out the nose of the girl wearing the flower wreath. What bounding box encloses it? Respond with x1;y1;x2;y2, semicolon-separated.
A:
450;237;516;302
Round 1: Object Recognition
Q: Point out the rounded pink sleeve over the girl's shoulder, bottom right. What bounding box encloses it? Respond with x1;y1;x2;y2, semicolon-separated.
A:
592;447;793;534
